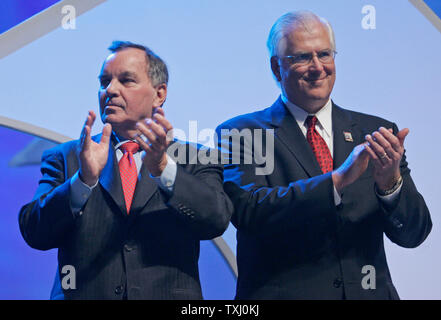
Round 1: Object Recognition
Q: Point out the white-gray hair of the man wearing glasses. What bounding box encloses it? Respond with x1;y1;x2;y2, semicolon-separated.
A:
266;11;336;57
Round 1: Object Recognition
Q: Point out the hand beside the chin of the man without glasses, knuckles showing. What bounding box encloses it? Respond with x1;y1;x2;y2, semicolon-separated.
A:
133;107;173;177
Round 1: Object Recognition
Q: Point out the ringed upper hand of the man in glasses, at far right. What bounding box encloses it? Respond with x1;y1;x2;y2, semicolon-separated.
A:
366;127;409;191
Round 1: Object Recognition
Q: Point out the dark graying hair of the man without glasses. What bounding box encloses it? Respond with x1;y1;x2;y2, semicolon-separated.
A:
108;41;168;87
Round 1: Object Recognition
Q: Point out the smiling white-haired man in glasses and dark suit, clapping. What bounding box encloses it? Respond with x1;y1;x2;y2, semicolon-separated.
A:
217;12;432;299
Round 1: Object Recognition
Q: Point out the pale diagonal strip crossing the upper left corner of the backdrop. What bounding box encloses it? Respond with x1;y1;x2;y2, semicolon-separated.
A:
0;0;107;59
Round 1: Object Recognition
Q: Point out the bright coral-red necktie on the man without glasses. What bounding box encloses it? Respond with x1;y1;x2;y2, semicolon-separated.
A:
119;141;139;214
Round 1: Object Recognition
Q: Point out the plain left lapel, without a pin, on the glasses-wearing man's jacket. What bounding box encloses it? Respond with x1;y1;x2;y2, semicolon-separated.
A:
270;97;322;177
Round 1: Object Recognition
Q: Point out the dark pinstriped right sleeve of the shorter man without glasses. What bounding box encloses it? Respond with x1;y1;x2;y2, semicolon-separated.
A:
167;148;233;240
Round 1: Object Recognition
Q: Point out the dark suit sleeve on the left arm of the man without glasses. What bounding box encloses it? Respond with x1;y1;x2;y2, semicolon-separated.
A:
19;150;74;250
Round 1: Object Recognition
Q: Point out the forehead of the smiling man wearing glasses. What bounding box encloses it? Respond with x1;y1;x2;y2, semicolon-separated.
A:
277;19;332;55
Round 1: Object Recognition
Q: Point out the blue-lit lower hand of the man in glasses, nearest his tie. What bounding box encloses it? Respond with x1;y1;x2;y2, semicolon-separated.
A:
332;143;369;193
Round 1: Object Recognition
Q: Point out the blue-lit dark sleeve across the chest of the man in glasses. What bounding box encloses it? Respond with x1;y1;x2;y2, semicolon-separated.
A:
217;125;336;236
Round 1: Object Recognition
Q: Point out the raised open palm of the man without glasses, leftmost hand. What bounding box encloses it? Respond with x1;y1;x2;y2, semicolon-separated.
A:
78;111;112;186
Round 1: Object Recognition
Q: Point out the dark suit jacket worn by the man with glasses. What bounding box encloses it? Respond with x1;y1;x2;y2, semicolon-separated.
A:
217;98;432;299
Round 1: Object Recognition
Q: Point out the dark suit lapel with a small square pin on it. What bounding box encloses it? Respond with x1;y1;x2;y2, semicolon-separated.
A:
332;103;364;168
